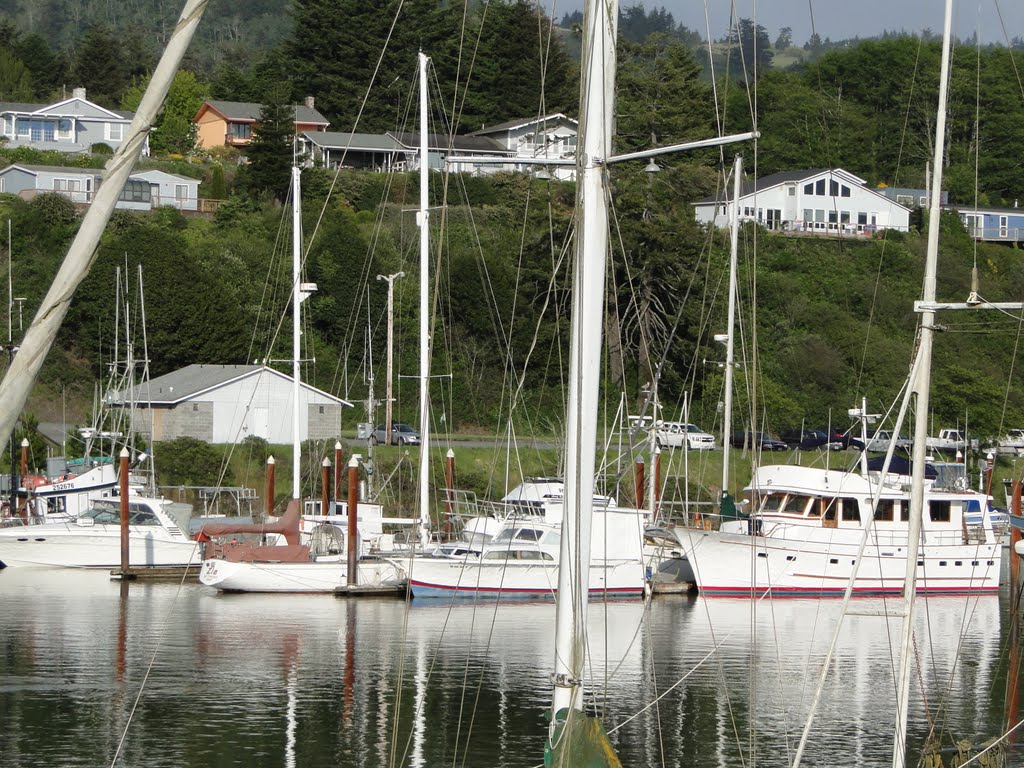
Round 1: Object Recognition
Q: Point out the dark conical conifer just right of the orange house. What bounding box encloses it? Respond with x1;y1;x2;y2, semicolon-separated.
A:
244;85;295;202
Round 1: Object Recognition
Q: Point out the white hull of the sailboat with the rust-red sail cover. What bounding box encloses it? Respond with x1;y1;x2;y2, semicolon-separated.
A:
199;559;406;593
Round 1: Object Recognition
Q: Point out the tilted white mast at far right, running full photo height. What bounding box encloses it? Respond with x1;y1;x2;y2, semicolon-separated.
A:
892;0;952;768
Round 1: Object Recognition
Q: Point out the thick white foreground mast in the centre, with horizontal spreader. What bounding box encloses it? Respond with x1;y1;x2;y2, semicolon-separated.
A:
552;0;618;723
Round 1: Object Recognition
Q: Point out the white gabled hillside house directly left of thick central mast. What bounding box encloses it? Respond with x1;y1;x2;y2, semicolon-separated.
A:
469;113;580;181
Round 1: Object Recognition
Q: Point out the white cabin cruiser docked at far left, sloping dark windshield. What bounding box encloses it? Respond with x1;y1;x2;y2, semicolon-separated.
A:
0;496;200;568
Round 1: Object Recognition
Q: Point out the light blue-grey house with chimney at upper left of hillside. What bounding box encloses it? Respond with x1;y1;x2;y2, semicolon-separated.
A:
0;88;150;155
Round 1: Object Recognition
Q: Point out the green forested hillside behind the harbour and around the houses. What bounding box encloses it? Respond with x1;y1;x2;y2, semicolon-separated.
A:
0;0;1024;450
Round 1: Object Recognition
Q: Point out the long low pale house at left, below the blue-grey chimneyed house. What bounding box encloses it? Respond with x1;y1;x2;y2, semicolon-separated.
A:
0;164;200;211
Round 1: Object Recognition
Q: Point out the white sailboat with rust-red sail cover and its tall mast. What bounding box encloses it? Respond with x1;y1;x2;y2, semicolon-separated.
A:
197;160;406;593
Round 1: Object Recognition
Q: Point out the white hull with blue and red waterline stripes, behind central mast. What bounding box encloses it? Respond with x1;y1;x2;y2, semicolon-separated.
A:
409;558;646;600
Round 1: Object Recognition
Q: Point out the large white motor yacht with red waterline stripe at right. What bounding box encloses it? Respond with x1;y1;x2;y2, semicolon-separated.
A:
676;465;1001;597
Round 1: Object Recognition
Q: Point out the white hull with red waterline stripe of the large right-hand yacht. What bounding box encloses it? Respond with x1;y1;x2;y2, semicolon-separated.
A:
676;526;1001;597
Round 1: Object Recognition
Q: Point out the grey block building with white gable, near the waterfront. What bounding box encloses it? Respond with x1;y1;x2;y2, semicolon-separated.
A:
114;365;352;444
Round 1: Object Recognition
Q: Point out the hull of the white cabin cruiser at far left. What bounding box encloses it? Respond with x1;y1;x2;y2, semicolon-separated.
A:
0;523;201;568
